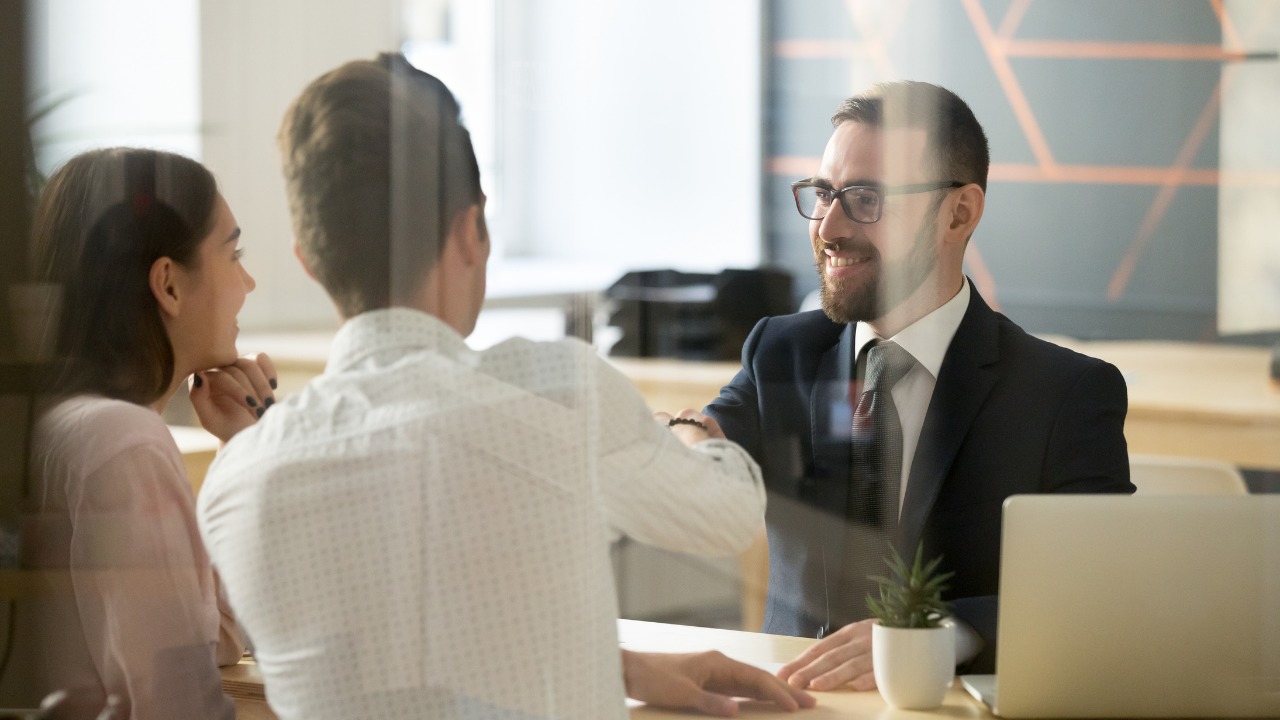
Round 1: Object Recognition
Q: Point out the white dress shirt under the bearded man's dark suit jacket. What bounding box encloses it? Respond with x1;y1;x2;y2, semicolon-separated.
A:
854;281;982;665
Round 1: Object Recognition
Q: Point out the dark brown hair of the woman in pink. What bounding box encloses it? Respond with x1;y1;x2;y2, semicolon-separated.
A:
32;147;218;405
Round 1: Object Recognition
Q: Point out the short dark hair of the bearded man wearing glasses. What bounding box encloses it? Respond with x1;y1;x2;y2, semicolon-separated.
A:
831;81;991;192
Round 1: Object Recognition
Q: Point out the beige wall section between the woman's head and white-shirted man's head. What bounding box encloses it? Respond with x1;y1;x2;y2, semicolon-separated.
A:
200;0;401;330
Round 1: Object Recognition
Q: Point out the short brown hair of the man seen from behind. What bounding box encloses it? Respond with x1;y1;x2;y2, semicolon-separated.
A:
279;54;480;318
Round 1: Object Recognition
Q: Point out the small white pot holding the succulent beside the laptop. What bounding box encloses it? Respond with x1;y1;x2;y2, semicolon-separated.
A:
872;620;956;710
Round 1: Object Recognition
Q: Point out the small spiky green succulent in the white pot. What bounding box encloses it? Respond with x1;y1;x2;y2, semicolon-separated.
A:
867;541;955;628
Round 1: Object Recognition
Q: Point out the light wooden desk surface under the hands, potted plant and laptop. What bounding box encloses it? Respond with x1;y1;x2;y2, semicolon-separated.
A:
223;620;992;720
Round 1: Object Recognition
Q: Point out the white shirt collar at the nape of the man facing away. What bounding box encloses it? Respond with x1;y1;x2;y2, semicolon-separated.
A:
325;307;470;373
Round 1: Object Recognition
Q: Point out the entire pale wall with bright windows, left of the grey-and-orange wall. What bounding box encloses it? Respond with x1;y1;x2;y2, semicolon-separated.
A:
32;0;763;331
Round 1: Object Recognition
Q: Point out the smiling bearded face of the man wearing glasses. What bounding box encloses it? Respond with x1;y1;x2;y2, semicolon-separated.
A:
809;122;942;323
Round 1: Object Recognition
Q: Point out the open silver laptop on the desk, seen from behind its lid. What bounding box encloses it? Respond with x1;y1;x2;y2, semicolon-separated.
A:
961;496;1280;717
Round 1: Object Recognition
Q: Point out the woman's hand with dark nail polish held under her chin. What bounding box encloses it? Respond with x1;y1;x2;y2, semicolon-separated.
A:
189;352;276;442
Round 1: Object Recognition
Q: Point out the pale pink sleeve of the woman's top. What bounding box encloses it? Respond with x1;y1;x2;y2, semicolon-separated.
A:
69;445;238;719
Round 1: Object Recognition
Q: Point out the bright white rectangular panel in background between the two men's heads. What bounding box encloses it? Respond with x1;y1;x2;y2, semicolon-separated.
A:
495;0;763;270
